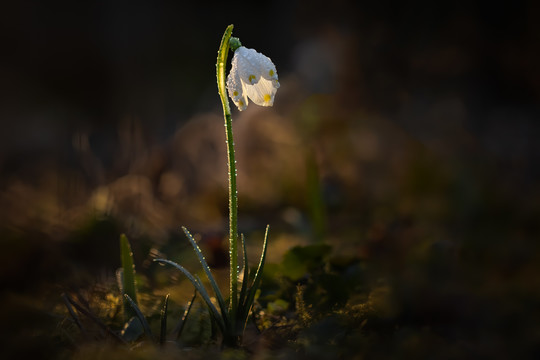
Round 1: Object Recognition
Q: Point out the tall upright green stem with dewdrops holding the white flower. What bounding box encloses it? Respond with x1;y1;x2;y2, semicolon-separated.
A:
216;25;238;331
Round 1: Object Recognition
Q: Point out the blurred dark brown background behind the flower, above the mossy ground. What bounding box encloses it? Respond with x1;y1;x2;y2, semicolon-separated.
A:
0;0;540;358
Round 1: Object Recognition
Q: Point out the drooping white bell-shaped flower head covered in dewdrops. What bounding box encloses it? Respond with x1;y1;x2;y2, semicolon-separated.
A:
227;46;279;111
